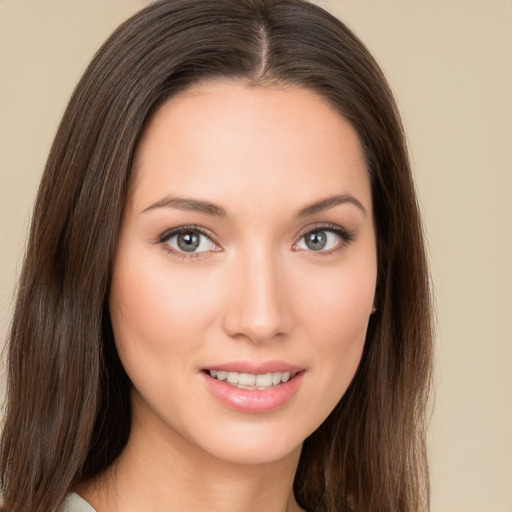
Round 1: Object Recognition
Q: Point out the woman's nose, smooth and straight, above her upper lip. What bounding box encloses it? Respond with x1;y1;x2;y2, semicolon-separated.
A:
223;245;292;343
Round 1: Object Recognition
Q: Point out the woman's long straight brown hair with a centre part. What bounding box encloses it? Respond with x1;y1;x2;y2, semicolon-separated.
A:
0;0;432;512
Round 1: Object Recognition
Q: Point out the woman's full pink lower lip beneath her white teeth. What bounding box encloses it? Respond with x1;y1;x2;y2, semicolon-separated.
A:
202;371;304;414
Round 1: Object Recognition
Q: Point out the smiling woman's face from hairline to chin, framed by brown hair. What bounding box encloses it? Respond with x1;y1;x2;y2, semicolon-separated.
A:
110;82;377;463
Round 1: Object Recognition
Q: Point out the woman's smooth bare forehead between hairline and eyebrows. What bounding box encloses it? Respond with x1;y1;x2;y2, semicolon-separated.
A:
132;81;371;214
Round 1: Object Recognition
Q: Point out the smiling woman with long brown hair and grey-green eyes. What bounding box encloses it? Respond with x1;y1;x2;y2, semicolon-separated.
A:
0;0;431;512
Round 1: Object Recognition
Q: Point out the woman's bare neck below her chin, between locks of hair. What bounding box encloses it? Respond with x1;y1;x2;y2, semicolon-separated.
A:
77;398;301;512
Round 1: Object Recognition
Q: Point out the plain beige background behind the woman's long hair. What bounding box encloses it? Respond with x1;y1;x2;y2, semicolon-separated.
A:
0;0;512;512
